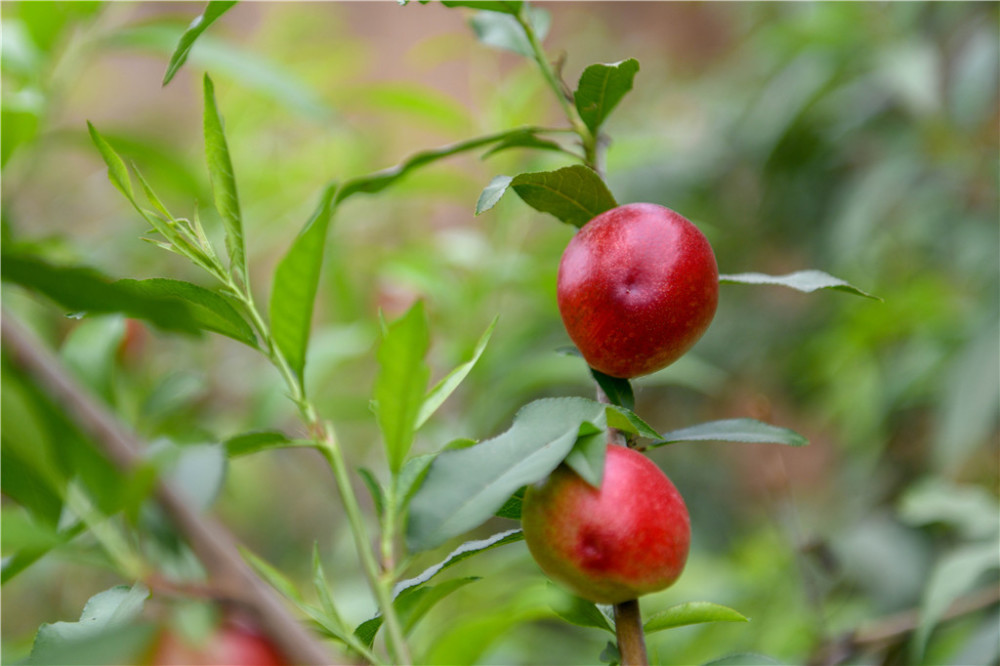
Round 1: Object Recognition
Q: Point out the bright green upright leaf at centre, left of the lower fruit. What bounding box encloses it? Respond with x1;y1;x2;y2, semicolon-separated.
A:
373;301;430;475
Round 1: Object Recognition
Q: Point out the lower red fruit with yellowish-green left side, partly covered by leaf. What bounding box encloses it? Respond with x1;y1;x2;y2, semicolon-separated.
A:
521;445;691;604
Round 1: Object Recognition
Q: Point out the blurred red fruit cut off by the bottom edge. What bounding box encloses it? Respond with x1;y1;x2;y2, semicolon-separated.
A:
149;622;289;666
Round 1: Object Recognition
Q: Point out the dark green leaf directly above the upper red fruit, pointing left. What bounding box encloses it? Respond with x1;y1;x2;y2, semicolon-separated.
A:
510;164;618;227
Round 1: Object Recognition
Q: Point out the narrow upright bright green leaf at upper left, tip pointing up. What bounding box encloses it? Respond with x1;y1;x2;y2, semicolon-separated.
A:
204;74;247;279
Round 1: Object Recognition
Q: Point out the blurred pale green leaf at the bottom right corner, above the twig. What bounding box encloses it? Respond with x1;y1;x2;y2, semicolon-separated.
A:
913;539;1000;662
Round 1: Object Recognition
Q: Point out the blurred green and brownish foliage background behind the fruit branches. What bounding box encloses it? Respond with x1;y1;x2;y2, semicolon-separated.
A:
0;2;1000;664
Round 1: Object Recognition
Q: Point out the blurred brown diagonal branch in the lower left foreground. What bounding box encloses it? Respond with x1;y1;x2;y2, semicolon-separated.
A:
0;311;330;665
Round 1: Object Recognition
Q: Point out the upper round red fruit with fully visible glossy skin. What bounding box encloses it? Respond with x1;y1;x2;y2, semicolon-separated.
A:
557;203;719;378
